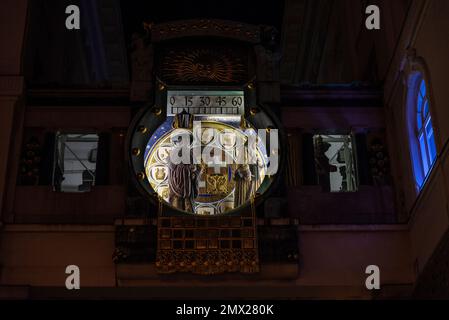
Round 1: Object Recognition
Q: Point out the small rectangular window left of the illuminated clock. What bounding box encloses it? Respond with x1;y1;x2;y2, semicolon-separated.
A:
53;133;99;192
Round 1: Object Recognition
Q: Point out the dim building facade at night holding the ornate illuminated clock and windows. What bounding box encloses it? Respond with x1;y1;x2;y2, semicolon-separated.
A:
0;0;449;299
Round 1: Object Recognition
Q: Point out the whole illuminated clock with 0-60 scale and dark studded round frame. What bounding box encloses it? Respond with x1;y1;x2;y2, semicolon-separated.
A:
130;87;279;215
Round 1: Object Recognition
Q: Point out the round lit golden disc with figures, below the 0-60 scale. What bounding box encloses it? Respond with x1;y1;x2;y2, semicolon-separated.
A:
144;118;268;215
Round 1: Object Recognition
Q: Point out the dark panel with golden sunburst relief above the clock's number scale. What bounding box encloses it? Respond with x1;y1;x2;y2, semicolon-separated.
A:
161;49;246;83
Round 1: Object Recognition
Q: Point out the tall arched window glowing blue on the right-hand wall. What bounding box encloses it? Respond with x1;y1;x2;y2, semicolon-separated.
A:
409;73;437;189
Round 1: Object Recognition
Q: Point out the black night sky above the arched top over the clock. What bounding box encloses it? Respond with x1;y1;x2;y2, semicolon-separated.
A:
121;0;284;39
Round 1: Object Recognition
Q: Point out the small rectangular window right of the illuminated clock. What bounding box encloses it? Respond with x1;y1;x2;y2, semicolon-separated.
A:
313;135;357;192
